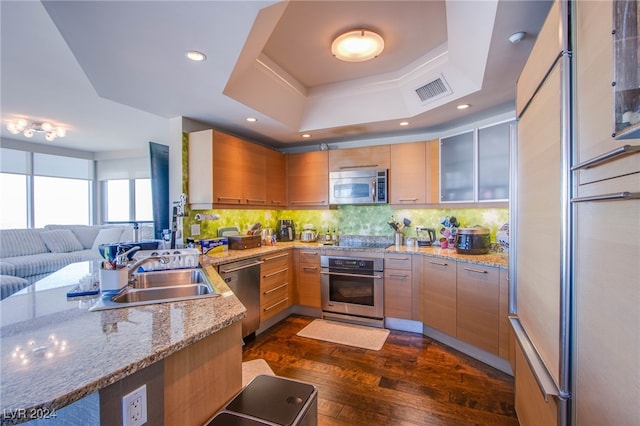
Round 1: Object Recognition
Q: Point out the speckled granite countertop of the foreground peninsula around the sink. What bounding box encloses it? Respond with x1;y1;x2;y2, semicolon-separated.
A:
0;262;246;423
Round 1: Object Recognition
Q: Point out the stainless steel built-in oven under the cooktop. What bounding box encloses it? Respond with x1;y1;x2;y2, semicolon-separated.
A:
320;256;384;327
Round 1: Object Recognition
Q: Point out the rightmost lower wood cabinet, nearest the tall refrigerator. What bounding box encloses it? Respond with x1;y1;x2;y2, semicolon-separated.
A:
456;262;500;355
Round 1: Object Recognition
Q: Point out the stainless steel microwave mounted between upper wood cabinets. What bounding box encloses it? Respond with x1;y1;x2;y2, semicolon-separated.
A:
329;169;389;204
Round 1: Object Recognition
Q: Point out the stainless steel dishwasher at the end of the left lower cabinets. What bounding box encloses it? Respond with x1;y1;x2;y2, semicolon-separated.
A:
218;257;263;337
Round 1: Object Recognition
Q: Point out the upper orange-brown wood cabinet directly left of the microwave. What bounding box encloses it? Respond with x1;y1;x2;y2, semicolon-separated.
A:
287;151;329;208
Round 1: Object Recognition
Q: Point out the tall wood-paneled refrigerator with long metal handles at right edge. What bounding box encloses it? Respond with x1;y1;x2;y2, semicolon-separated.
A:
510;0;640;426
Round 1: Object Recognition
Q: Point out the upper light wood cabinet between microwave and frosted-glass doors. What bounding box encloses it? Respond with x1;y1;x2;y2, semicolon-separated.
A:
389;140;439;205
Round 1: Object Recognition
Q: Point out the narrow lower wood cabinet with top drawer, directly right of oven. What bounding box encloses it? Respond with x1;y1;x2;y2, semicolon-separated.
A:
384;253;413;320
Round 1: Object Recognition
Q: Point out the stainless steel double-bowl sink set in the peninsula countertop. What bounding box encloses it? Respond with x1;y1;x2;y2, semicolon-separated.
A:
89;269;220;311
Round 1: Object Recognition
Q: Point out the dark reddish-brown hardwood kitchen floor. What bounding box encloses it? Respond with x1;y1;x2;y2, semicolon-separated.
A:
243;315;518;426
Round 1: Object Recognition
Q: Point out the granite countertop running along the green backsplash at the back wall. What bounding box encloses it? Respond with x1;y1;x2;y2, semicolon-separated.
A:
200;241;509;269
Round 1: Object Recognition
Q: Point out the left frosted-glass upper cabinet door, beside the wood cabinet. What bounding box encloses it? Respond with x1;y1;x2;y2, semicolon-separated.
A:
440;131;475;202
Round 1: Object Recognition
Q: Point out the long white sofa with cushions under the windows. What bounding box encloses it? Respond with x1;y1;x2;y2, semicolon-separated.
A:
0;225;153;299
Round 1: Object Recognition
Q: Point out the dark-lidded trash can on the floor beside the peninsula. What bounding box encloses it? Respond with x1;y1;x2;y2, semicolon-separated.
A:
207;375;318;426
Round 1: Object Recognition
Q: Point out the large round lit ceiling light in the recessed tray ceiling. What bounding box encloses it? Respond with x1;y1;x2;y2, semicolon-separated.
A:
331;30;384;62
